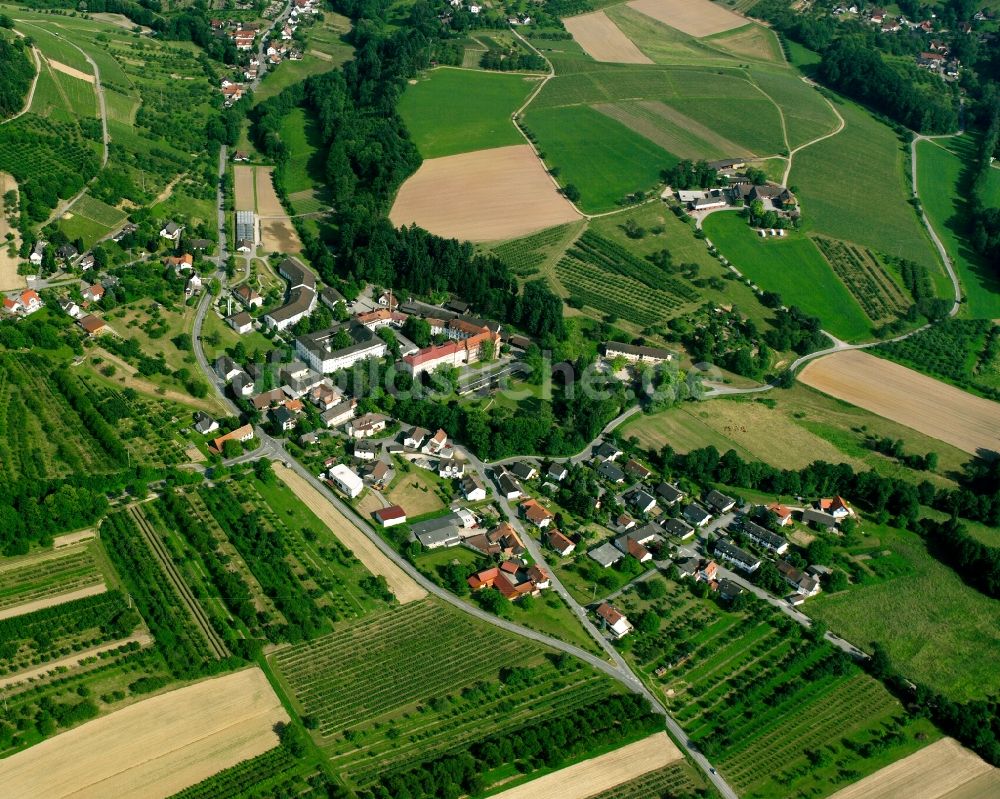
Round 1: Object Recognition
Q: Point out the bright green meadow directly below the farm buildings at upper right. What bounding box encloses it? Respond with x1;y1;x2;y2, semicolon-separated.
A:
704;212;871;341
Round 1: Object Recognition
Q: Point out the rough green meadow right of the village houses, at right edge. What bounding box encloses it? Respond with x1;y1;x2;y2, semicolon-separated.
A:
808;523;1000;700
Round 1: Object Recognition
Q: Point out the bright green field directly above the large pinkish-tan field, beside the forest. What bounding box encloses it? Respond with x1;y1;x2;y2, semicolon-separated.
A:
399;67;538;158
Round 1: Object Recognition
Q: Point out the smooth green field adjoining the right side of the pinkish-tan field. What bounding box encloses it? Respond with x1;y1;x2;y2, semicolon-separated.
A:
525;106;677;213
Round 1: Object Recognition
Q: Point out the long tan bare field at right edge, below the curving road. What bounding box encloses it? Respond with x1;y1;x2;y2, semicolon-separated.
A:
799;350;1000;453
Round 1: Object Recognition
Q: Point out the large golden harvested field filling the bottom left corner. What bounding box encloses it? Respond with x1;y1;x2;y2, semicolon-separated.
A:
0;668;288;799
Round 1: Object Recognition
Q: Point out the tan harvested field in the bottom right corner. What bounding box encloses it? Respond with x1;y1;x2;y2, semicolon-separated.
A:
830;738;1000;799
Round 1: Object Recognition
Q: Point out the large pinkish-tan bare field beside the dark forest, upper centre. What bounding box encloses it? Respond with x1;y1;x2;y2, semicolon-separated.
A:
389;144;580;241
